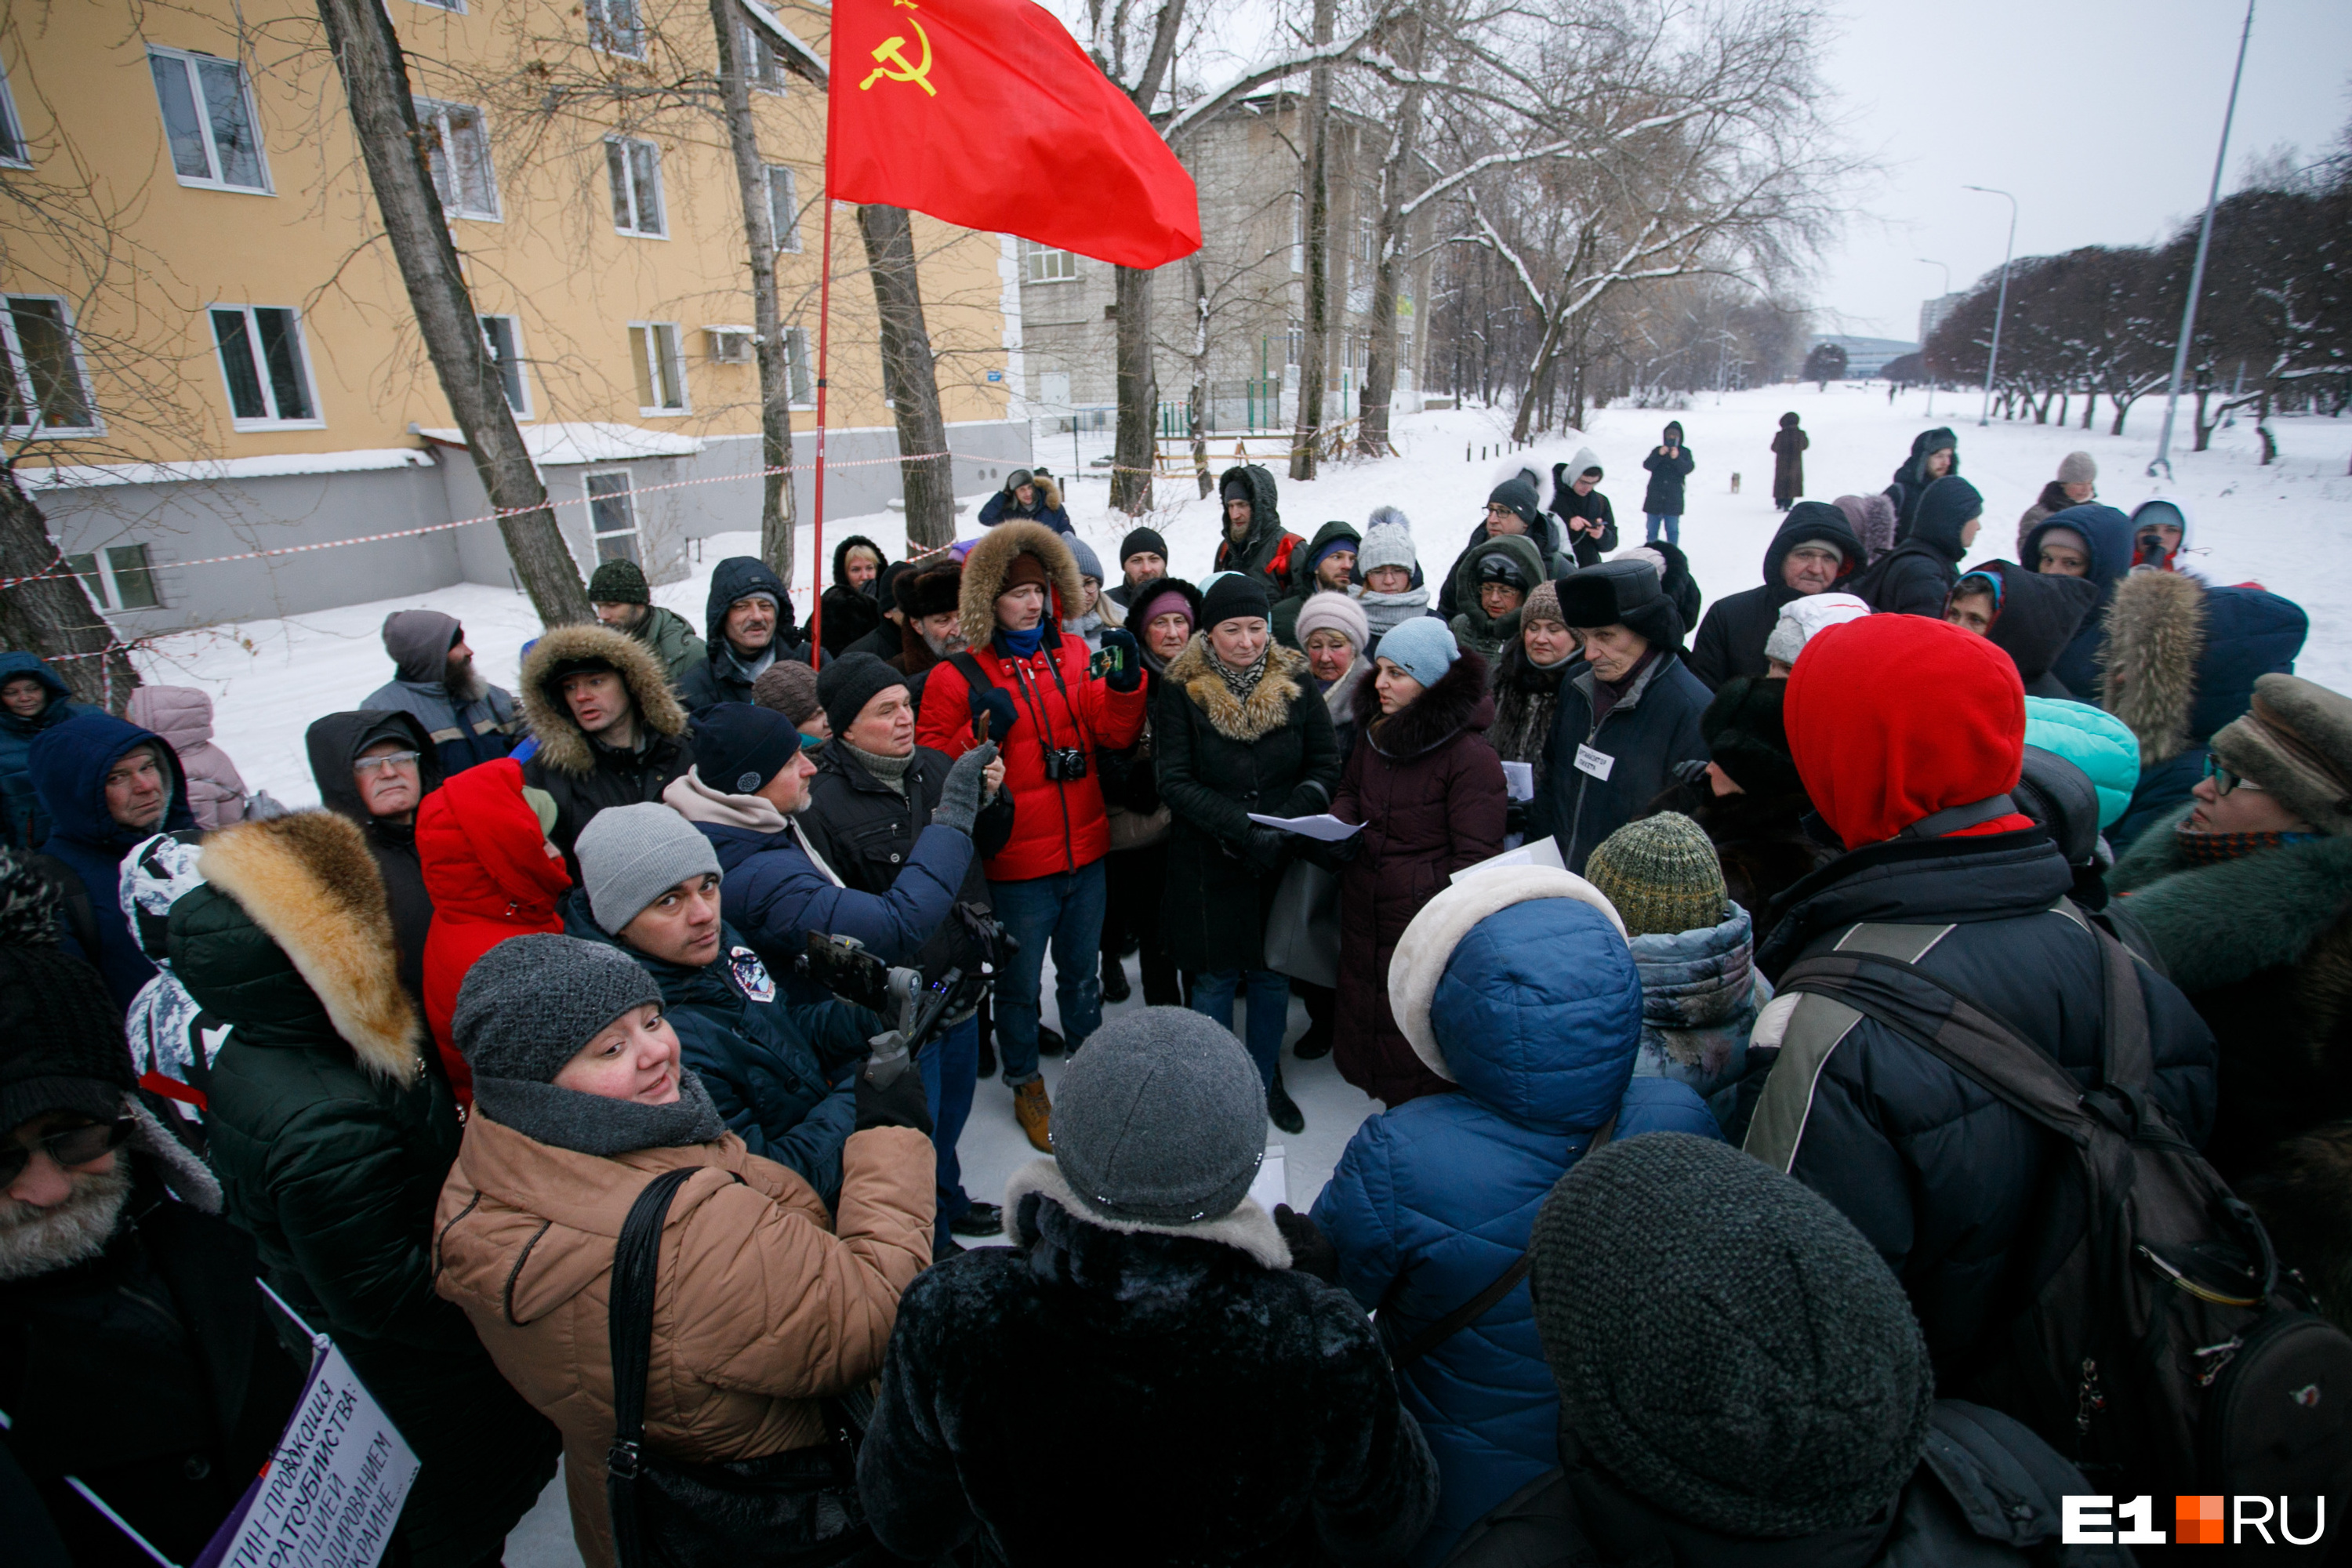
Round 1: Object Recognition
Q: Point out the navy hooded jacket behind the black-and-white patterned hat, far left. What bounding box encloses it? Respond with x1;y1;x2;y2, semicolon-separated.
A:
31;713;195;1011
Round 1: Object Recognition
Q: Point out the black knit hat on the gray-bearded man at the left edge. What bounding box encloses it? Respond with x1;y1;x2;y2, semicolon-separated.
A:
0;848;136;1135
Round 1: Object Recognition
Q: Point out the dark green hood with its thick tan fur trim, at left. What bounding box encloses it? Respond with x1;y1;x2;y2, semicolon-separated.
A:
172;811;423;1083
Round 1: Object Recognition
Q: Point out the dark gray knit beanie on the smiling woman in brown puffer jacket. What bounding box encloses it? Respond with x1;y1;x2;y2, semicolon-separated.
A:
449;926;663;1083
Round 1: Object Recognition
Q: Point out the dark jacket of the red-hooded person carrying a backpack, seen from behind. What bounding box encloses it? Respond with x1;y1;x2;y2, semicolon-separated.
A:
1748;827;2216;1389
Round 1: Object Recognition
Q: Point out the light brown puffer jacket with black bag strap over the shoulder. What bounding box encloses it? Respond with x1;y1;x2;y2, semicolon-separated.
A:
435;1114;934;1568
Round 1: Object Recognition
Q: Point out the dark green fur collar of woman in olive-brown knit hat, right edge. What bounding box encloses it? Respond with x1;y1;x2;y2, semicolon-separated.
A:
2110;806;2352;996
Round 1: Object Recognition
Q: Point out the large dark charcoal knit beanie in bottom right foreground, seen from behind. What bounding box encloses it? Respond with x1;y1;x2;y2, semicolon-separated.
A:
1529;1133;1936;1540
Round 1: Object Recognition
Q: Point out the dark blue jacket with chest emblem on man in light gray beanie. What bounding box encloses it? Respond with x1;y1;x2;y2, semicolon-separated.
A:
564;888;884;1208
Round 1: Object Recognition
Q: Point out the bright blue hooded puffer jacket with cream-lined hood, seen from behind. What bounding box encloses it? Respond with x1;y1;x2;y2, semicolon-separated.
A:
1315;898;1722;1563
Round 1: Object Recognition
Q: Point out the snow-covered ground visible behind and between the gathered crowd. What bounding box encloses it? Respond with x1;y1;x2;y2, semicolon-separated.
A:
141;383;2352;1206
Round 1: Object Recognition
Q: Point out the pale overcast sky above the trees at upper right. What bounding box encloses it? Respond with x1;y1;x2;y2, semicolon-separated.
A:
1813;0;2352;339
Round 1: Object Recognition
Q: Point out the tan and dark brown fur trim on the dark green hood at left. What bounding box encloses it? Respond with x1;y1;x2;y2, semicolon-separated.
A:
195;811;423;1083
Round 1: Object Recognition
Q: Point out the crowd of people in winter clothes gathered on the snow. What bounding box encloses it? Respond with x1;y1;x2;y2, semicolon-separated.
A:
0;430;2352;1568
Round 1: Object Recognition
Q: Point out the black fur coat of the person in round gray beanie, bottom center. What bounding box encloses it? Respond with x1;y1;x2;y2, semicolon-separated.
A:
858;1161;1437;1568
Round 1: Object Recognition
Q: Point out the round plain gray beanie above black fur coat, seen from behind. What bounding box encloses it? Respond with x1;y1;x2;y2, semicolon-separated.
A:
1054;1006;1265;1225
